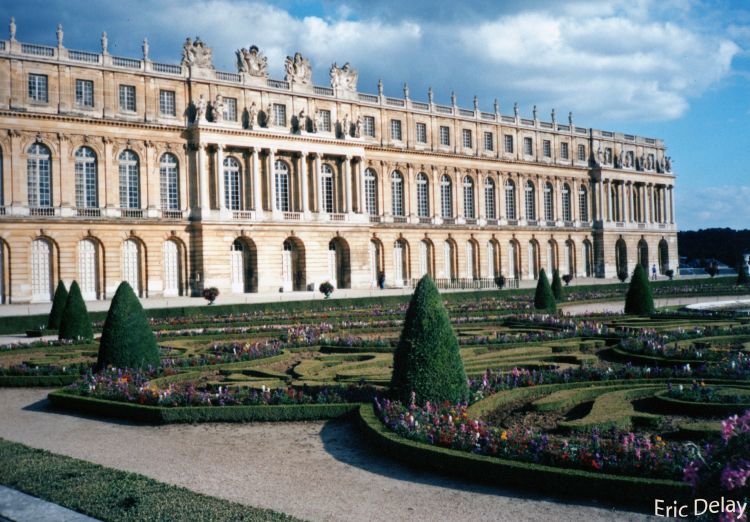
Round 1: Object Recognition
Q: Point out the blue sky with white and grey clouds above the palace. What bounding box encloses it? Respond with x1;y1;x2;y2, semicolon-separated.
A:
0;0;750;230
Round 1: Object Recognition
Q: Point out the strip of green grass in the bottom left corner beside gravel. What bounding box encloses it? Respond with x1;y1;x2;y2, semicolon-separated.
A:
0;439;298;522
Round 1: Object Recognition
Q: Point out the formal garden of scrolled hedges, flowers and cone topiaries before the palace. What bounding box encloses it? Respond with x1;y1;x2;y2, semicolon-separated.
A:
0;272;750;509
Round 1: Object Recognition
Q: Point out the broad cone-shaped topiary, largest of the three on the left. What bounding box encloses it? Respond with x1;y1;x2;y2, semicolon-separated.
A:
96;281;160;370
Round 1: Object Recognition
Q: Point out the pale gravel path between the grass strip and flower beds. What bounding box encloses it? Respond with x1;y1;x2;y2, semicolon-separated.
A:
0;388;647;522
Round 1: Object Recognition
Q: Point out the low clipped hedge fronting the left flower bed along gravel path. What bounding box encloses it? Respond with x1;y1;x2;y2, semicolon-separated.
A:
47;390;359;424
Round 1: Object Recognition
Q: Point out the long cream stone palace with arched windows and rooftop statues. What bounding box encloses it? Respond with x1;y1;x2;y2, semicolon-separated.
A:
0;21;677;303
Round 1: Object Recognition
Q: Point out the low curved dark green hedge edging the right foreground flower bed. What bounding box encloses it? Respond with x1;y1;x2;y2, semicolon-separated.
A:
357;404;692;511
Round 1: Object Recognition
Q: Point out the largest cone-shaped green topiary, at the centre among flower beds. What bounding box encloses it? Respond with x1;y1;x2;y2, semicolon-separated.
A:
391;275;469;404
